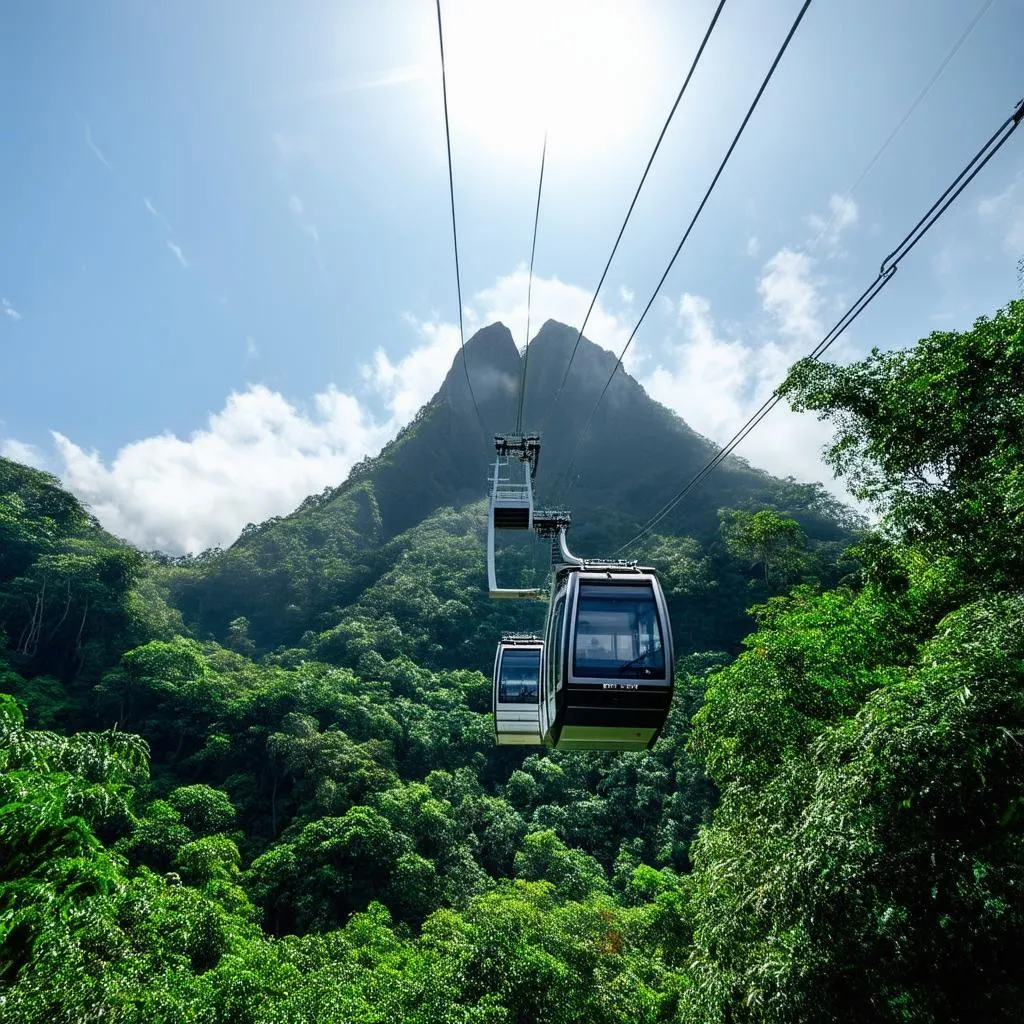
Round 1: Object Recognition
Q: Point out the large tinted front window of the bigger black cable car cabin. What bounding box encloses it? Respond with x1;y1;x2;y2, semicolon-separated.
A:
572;583;666;682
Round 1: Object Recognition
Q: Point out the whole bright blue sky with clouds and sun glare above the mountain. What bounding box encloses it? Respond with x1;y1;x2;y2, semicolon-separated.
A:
0;0;1024;551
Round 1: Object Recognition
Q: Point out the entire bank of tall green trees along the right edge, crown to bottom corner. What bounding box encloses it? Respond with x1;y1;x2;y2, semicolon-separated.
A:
681;302;1024;1024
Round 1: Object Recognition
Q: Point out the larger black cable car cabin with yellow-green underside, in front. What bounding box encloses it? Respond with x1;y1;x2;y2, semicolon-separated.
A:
541;563;673;751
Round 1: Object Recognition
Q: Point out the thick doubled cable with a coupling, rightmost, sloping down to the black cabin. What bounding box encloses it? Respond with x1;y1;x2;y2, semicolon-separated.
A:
614;99;1024;555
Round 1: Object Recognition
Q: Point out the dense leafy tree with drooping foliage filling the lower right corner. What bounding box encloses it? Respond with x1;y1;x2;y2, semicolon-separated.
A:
684;597;1024;1024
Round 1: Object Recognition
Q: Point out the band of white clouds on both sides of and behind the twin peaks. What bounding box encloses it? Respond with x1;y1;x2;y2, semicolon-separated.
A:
9;197;864;552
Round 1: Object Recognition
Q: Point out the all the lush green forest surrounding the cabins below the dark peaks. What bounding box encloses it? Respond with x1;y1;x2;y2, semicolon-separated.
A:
0;302;1024;1024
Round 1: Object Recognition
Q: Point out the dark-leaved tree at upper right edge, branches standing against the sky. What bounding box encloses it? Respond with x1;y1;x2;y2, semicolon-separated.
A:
779;299;1024;587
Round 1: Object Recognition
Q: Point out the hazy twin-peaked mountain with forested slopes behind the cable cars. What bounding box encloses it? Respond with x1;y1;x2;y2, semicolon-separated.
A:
171;321;856;651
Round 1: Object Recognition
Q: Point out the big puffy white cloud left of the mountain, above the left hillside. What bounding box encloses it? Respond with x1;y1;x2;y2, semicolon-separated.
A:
53;385;390;552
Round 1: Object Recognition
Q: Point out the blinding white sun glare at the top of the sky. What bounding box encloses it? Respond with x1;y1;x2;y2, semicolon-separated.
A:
443;0;659;162
